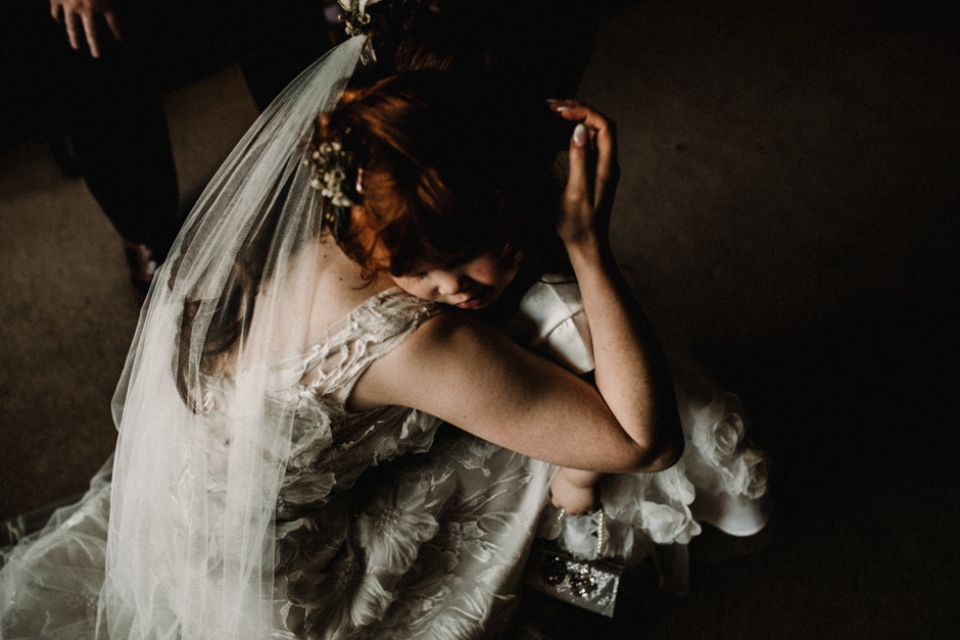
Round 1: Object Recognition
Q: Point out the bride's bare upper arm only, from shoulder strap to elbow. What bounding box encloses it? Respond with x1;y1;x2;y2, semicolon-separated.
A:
351;310;674;472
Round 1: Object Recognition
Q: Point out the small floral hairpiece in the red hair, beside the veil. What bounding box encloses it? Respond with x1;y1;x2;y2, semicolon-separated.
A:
307;136;363;244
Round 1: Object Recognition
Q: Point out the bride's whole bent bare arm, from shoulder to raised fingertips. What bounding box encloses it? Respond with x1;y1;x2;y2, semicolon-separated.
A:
352;101;683;472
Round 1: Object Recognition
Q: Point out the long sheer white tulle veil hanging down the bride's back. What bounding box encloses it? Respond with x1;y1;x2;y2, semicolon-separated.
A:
98;37;364;640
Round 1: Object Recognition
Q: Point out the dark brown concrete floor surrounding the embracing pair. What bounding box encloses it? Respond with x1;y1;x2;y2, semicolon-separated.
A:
0;0;960;639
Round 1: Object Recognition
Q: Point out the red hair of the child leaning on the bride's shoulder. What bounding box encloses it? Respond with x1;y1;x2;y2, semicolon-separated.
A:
310;71;551;277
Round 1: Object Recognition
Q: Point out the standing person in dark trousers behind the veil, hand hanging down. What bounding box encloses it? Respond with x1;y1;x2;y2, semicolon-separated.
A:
29;0;331;300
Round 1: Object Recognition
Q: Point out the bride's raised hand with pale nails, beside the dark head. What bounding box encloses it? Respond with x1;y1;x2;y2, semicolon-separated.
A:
550;100;620;248
